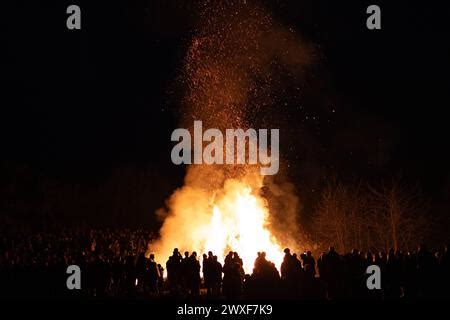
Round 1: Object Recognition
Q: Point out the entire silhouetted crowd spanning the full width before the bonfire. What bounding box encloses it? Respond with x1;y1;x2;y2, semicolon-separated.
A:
0;229;450;300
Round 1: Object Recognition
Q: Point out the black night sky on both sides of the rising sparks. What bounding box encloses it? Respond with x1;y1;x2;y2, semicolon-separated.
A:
0;0;450;229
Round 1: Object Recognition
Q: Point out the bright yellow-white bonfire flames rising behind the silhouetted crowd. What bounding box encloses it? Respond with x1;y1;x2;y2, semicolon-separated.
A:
152;166;283;273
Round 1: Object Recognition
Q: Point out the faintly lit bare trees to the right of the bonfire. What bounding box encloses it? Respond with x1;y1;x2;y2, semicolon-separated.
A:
314;180;432;252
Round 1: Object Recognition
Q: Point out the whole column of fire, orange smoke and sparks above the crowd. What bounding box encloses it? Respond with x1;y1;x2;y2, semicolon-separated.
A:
152;1;314;272
